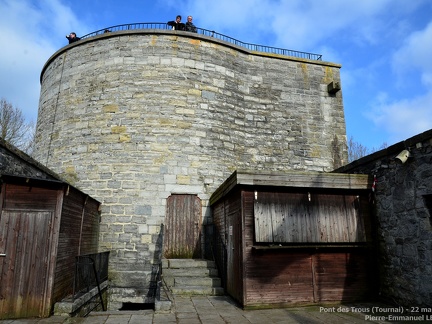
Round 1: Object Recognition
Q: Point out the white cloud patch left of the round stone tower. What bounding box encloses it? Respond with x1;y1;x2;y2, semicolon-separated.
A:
0;0;88;121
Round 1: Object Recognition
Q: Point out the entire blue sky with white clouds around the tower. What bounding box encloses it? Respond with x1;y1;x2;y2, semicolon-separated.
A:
0;0;432;149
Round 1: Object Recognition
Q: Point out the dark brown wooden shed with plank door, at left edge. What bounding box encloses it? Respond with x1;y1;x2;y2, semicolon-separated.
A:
0;174;100;319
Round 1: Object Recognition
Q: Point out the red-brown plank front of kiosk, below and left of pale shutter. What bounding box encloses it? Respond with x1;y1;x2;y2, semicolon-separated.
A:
242;191;377;308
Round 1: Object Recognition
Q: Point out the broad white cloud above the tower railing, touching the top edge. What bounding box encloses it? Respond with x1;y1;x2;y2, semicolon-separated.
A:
177;0;424;50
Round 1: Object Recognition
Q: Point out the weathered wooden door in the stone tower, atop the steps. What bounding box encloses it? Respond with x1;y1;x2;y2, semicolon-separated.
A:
164;194;202;258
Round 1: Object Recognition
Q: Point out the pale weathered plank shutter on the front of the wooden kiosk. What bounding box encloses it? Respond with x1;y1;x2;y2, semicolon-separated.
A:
254;192;369;243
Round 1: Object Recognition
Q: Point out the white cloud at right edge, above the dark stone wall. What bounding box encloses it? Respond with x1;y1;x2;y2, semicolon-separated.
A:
368;19;432;141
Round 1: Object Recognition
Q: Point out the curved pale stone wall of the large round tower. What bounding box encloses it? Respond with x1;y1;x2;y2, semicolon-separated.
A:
35;30;347;307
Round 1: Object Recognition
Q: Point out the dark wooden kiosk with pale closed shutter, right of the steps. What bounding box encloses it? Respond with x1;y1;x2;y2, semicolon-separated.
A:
210;171;377;308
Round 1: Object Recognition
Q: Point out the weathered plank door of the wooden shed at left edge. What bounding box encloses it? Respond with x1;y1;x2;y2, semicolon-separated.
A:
0;210;53;319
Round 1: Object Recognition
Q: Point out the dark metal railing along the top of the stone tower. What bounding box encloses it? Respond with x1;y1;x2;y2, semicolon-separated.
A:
81;23;322;61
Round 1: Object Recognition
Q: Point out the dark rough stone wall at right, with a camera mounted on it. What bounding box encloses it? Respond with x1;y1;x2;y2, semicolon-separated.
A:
336;130;432;308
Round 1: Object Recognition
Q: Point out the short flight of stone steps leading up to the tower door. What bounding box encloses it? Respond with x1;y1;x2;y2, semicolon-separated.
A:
162;259;224;296
